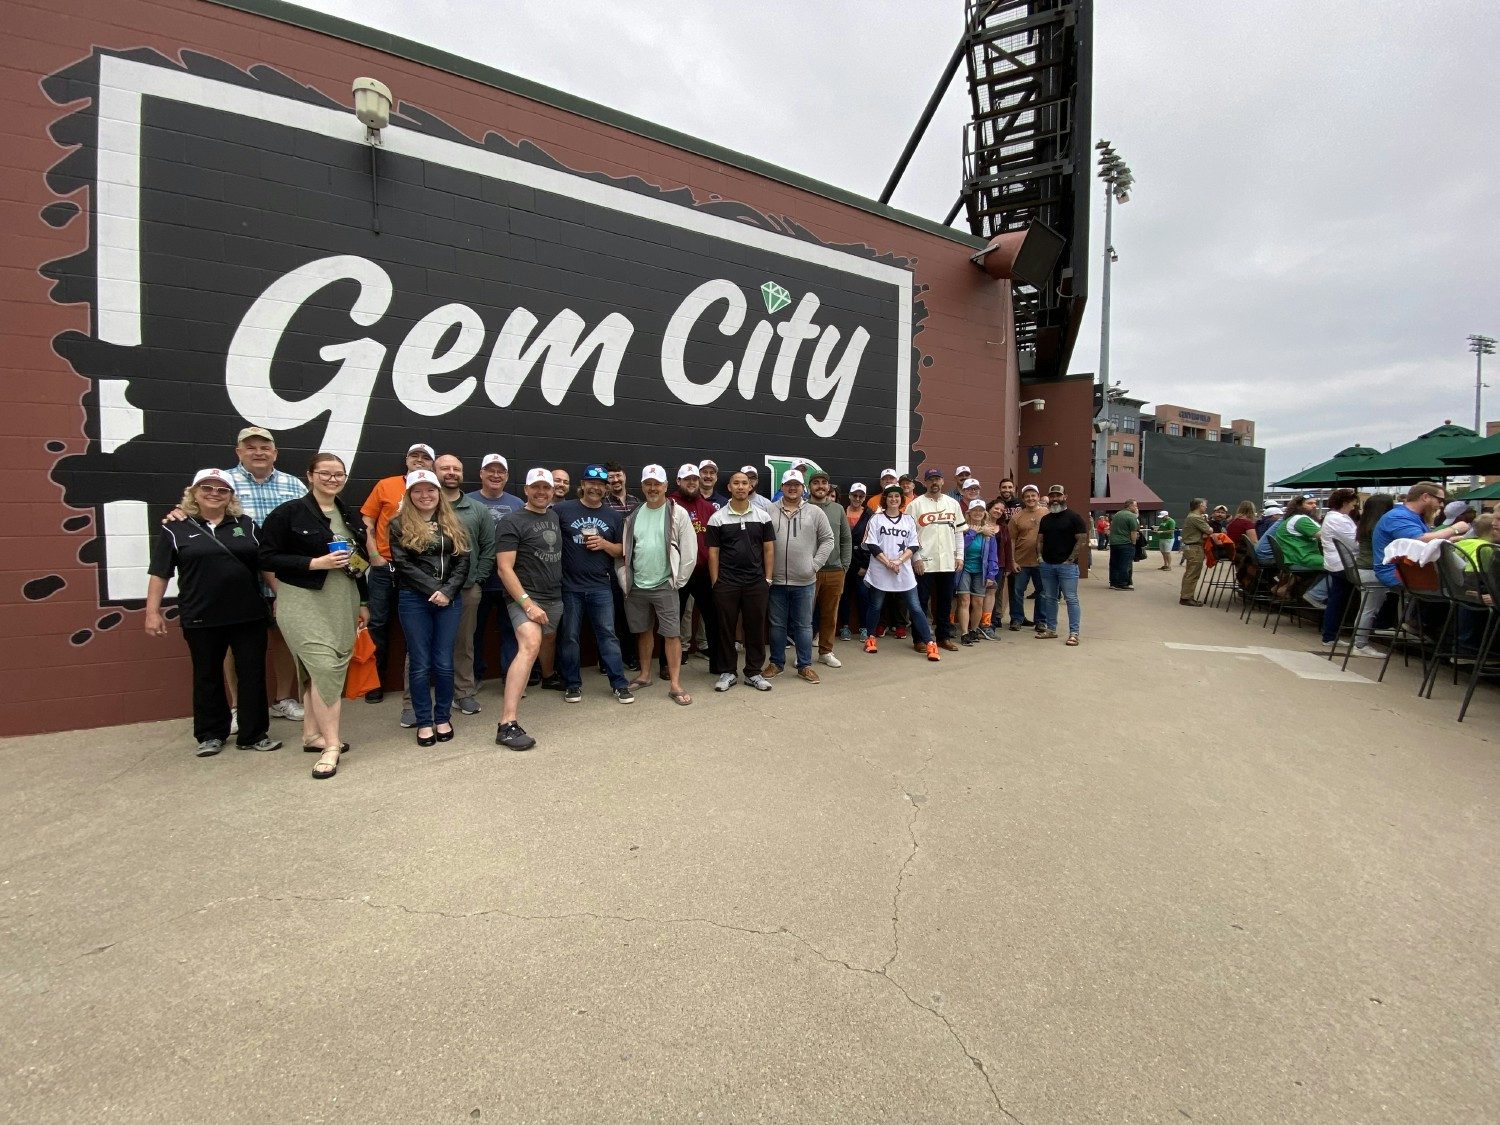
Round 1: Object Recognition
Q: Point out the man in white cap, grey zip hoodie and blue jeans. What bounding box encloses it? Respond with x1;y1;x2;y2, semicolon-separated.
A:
764;470;836;684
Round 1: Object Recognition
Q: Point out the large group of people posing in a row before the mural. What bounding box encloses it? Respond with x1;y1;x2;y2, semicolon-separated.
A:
146;426;1089;779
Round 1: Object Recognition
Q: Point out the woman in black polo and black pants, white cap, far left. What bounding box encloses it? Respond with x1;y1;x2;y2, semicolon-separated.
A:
146;470;281;758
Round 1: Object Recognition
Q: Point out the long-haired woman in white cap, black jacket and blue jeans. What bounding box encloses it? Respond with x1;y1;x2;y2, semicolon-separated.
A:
386;470;470;746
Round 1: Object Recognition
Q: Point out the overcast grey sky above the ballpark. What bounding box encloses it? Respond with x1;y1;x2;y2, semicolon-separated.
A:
289;0;1500;480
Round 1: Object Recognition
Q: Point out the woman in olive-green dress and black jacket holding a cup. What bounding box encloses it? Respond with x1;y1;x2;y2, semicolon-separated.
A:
261;453;369;780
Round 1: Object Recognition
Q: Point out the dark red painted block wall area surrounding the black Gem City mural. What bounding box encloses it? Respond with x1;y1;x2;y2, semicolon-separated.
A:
0;0;1032;735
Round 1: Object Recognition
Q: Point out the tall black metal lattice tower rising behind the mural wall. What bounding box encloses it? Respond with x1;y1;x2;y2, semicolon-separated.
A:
950;0;1094;378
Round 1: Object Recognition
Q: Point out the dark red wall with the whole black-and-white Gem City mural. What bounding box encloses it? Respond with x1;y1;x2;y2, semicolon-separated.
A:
0;0;1016;734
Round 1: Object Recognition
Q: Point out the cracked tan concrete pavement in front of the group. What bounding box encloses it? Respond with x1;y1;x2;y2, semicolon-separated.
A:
0;566;1500;1125
